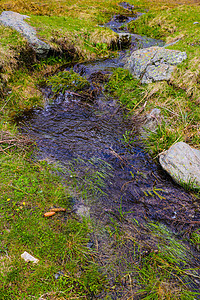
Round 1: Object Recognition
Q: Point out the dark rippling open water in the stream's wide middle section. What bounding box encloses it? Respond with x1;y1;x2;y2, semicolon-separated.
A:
18;77;199;226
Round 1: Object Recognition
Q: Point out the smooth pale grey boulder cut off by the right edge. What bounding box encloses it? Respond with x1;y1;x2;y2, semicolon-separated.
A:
159;142;200;187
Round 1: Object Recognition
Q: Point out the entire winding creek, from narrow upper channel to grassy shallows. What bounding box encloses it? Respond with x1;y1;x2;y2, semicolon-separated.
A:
19;4;200;299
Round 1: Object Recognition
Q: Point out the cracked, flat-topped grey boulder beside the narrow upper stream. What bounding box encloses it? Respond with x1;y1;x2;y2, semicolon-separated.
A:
125;46;187;83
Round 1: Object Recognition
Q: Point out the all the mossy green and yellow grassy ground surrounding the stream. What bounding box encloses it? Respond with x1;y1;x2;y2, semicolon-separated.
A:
0;0;200;299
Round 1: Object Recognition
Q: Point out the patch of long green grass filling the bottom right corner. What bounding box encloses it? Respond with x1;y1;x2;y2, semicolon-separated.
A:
127;223;198;300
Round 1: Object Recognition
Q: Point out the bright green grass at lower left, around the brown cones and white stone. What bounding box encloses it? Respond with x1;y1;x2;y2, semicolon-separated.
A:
0;137;105;299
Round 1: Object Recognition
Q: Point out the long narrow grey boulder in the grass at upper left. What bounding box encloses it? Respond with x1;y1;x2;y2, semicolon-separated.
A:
0;11;51;57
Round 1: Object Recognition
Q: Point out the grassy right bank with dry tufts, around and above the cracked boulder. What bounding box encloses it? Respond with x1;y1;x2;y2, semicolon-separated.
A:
129;1;200;154
